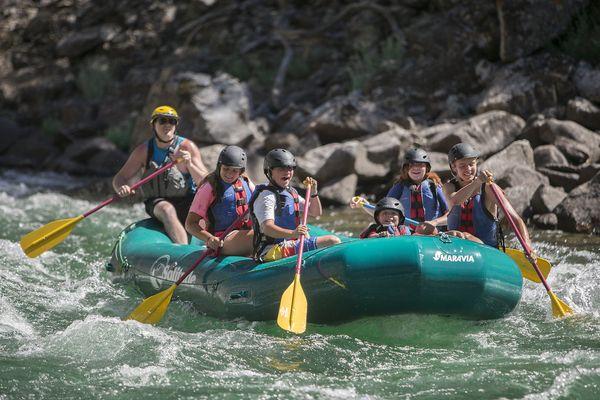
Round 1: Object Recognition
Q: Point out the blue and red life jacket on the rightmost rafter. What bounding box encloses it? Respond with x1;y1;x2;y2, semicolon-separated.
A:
448;183;504;247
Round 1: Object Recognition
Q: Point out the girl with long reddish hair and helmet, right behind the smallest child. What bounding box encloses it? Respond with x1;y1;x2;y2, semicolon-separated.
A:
350;148;449;235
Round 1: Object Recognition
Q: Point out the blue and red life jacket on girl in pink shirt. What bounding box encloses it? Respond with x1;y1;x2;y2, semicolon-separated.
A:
207;177;252;234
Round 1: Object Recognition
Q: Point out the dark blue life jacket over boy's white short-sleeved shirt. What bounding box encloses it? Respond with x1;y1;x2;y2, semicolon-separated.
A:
249;184;300;261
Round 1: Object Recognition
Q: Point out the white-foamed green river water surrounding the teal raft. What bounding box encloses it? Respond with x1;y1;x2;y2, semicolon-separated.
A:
0;171;600;399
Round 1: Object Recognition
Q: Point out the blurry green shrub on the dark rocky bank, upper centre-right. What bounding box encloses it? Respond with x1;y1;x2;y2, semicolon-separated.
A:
348;36;405;90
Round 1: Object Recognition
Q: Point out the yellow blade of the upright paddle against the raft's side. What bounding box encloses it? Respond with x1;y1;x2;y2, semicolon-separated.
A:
277;274;308;333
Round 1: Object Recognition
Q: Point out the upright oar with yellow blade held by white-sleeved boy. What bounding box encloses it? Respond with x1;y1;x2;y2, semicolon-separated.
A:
277;180;311;333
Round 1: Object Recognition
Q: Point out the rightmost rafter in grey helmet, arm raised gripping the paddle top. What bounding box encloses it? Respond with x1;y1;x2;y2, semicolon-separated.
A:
444;143;532;262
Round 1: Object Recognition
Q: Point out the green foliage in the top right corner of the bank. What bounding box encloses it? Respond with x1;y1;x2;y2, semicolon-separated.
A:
554;2;600;64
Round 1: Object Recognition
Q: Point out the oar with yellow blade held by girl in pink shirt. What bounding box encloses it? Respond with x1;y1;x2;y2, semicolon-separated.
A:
125;210;248;324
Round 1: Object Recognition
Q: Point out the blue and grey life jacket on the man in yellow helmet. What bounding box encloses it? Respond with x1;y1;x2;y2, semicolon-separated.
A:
142;136;196;199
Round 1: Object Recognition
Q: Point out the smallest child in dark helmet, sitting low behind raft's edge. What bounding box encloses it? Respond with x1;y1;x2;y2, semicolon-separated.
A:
360;197;410;239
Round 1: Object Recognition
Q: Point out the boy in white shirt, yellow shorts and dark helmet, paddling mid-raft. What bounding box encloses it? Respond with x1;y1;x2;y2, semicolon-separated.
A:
250;149;340;262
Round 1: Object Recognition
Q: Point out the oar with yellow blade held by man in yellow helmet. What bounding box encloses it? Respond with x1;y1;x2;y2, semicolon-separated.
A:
21;159;180;258
